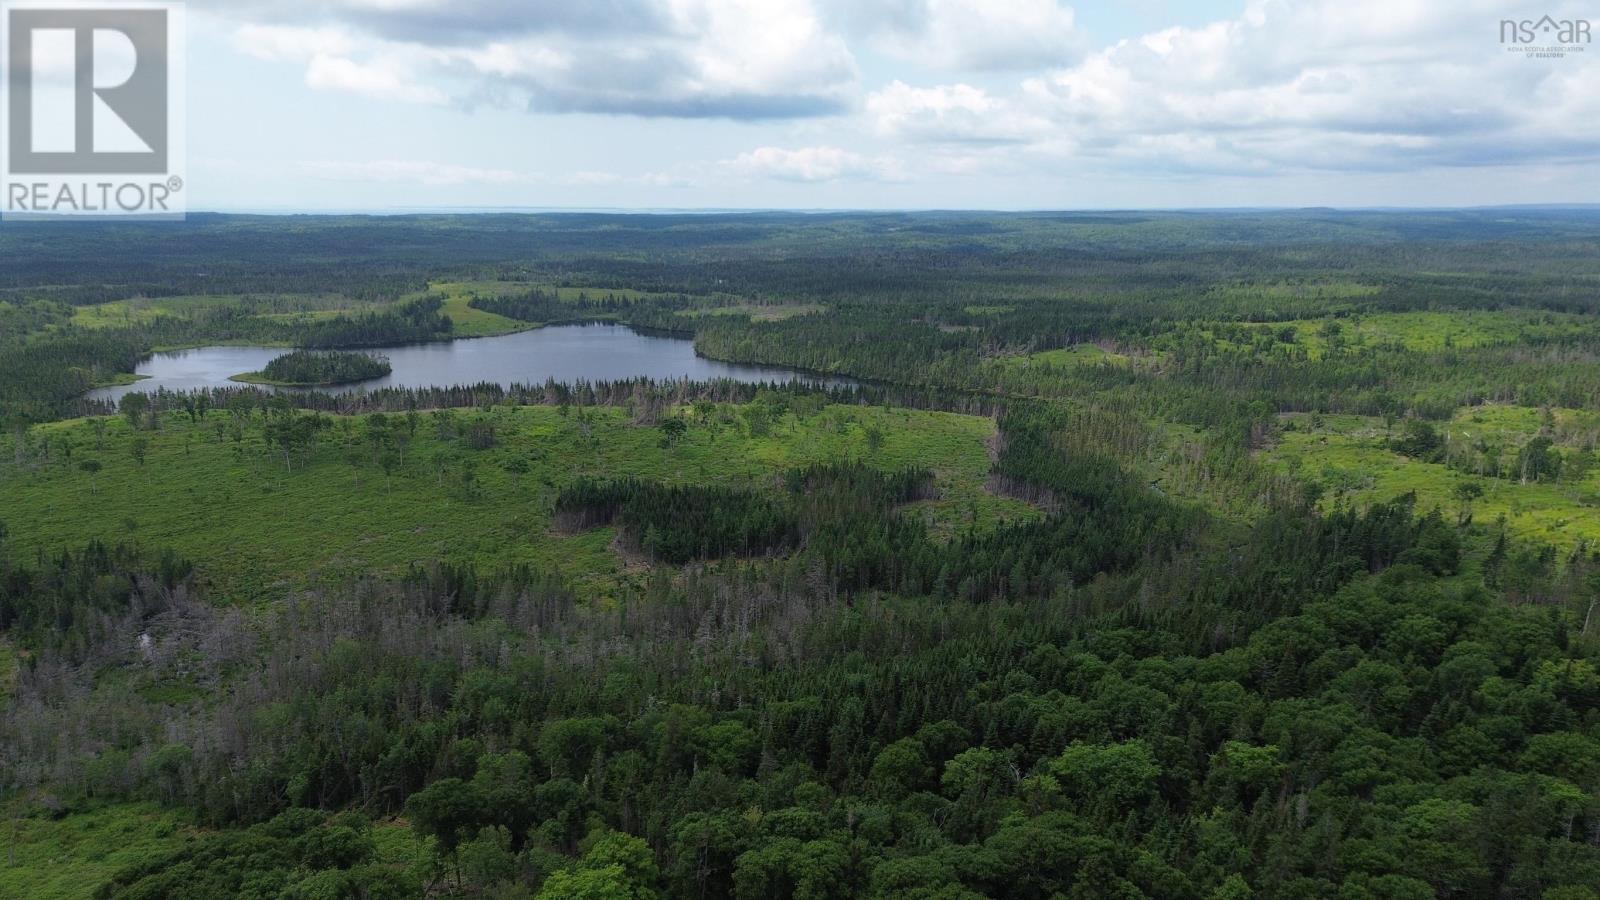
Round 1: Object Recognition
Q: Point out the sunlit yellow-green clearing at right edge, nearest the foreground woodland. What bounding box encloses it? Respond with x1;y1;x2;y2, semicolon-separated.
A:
1264;407;1600;549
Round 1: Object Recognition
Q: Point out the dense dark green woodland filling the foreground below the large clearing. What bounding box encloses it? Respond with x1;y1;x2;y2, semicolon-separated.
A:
0;408;1600;897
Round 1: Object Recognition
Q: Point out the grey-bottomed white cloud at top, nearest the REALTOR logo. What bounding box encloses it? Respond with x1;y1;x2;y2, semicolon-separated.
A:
235;0;858;119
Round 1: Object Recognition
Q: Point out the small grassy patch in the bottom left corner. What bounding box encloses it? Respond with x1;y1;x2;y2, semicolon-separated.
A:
0;804;194;900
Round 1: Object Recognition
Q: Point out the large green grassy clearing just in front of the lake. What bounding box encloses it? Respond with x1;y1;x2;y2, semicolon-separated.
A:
0;405;1037;601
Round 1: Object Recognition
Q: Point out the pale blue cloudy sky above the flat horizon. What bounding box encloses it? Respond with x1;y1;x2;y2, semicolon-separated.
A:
165;0;1600;210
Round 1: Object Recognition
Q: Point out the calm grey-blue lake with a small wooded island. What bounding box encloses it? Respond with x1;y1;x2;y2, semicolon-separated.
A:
88;325;851;400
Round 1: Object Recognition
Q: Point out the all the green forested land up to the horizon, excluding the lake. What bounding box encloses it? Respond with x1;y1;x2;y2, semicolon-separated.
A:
0;208;1600;900
